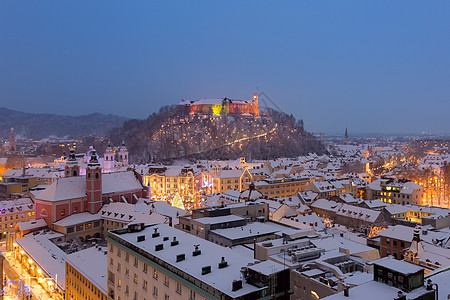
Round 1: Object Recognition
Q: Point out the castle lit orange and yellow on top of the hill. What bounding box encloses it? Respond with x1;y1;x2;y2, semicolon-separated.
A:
180;93;259;117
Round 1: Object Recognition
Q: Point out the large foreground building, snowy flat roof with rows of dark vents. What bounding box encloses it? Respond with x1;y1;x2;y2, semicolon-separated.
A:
107;223;290;300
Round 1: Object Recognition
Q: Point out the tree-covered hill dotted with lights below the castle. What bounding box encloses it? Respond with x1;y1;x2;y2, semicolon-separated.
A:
109;105;326;163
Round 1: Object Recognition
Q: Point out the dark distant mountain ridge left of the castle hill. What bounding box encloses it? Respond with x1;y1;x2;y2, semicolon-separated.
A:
0;107;128;139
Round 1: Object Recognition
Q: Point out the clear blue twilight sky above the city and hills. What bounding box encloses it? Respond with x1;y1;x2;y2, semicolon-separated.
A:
0;0;450;134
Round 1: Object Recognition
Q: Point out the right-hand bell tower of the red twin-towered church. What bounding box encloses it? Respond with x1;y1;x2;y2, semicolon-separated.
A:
86;149;103;214
